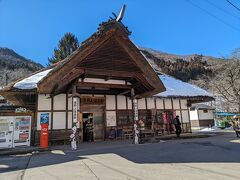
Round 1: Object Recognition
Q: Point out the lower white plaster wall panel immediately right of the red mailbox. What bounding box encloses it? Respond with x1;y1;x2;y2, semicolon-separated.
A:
53;112;66;129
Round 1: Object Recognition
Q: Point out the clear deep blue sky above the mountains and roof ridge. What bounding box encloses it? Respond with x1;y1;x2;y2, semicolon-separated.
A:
0;0;240;65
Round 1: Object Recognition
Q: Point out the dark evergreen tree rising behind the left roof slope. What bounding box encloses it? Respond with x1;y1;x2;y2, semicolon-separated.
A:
48;32;79;65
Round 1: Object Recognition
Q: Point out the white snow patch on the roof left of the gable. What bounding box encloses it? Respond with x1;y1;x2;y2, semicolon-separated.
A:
13;69;52;89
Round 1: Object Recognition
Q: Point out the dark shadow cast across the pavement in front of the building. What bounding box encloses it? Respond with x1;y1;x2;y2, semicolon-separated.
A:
0;133;240;173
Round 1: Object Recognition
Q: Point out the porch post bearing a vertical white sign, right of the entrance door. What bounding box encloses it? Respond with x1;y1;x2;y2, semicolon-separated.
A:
131;88;139;144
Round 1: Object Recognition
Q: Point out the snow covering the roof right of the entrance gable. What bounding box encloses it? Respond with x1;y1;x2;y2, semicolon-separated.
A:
155;75;213;97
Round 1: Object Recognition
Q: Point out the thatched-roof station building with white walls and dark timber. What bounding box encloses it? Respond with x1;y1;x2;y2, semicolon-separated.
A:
0;12;213;144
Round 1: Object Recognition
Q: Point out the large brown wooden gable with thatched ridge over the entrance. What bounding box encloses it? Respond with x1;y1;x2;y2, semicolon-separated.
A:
38;21;165;97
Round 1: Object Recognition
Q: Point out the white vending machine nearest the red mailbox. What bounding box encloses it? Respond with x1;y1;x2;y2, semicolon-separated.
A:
13;116;31;147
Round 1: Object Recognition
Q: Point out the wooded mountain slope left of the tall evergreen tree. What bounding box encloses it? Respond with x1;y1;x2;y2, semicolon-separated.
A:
0;47;43;87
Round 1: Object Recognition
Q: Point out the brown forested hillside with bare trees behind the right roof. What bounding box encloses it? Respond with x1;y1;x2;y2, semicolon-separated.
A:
141;48;240;112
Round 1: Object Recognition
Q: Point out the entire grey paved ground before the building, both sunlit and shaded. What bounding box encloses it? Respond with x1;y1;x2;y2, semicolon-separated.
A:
0;132;240;180
